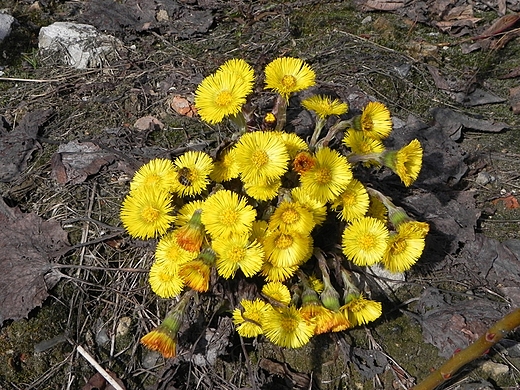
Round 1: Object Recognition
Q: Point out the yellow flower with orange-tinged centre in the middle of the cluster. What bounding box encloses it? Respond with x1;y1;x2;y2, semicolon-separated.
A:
269;200;314;234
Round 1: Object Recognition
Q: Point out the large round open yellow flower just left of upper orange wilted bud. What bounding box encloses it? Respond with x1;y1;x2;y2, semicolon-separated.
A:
235;131;289;183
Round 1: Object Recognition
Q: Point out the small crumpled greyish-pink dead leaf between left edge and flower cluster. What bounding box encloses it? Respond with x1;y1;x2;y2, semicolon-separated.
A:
51;141;115;184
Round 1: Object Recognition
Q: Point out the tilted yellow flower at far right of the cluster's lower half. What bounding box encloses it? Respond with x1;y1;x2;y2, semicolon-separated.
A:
382;221;426;272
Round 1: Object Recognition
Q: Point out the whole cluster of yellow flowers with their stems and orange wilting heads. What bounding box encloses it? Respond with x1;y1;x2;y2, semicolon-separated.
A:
121;57;428;357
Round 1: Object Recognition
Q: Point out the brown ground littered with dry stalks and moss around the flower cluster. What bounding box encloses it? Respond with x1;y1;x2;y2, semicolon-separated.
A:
0;0;520;390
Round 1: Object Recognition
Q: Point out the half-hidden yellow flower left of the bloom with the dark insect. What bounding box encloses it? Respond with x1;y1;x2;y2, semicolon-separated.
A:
130;158;175;191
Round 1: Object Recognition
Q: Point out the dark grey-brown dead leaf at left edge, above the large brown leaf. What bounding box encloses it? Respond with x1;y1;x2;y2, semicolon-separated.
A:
0;110;53;183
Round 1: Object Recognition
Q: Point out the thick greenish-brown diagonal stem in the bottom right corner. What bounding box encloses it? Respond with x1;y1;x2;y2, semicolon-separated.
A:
413;309;520;390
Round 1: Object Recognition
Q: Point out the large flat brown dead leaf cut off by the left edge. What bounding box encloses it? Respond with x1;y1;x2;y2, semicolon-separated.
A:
0;206;68;325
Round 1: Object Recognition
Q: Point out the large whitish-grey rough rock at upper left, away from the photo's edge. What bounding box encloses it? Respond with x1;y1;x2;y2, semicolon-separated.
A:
38;22;123;69
